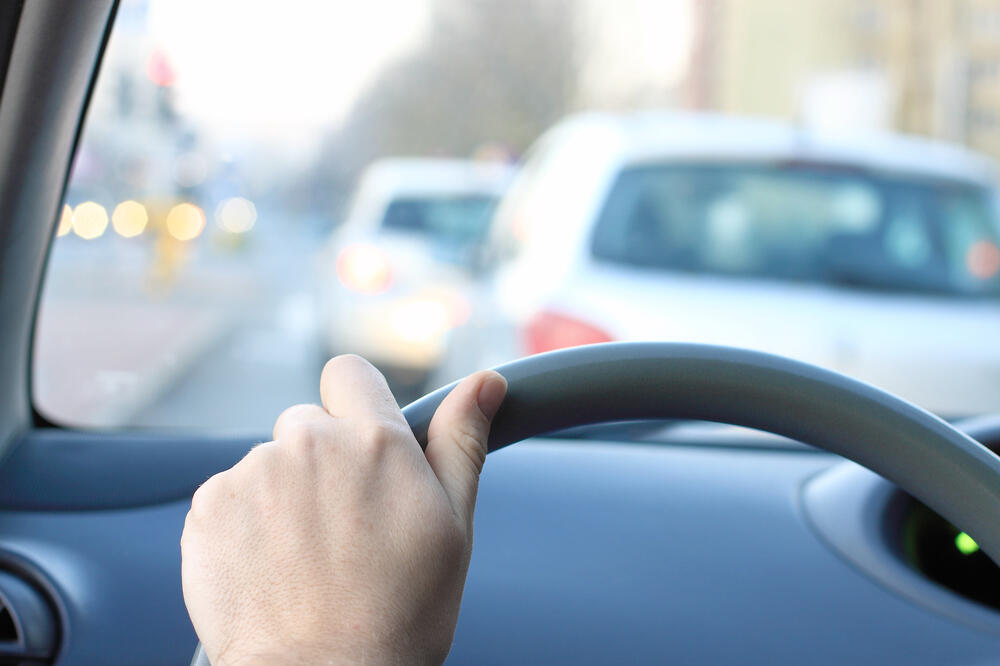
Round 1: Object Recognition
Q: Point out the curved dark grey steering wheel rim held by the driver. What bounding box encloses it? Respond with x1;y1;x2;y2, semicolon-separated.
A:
192;342;1000;666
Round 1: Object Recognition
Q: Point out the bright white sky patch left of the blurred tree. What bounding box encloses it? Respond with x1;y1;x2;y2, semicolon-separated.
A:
147;0;427;150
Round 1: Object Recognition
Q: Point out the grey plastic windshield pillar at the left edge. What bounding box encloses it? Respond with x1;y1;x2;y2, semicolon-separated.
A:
0;0;117;455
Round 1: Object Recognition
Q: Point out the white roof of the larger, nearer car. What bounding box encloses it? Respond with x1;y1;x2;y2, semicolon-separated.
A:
549;111;995;186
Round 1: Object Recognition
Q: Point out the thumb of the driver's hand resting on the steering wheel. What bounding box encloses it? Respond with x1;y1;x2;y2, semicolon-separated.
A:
426;370;507;524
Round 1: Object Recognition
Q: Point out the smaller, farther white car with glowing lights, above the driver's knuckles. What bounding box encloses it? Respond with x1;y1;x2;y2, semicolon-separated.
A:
320;158;513;390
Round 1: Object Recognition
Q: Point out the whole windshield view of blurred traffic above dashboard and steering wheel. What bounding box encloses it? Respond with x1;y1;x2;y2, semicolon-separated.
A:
32;0;1000;430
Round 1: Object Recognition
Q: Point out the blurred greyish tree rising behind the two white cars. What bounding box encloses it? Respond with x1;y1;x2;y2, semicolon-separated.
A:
311;0;580;220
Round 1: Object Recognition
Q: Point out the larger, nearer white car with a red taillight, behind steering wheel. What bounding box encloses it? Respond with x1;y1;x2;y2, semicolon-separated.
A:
438;113;1000;416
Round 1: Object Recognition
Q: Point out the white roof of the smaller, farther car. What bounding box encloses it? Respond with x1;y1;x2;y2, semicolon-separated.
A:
359;157;514;199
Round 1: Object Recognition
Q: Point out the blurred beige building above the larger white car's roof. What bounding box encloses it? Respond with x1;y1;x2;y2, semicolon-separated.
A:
684;0;1000;157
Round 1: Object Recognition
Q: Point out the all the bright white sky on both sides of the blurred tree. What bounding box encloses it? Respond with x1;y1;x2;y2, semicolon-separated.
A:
146;0;691;151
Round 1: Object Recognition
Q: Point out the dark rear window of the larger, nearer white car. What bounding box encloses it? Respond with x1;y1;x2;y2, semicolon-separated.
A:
592;164;1000;295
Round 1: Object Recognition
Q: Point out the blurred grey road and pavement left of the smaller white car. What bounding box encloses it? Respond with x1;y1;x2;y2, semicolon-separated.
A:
33;220;321;437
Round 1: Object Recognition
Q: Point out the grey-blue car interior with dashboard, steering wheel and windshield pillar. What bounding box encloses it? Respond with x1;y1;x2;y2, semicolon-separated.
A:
0;0;1000;666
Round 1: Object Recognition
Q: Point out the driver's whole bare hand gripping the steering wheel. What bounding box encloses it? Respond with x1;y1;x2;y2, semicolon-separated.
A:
181;356;506;666
